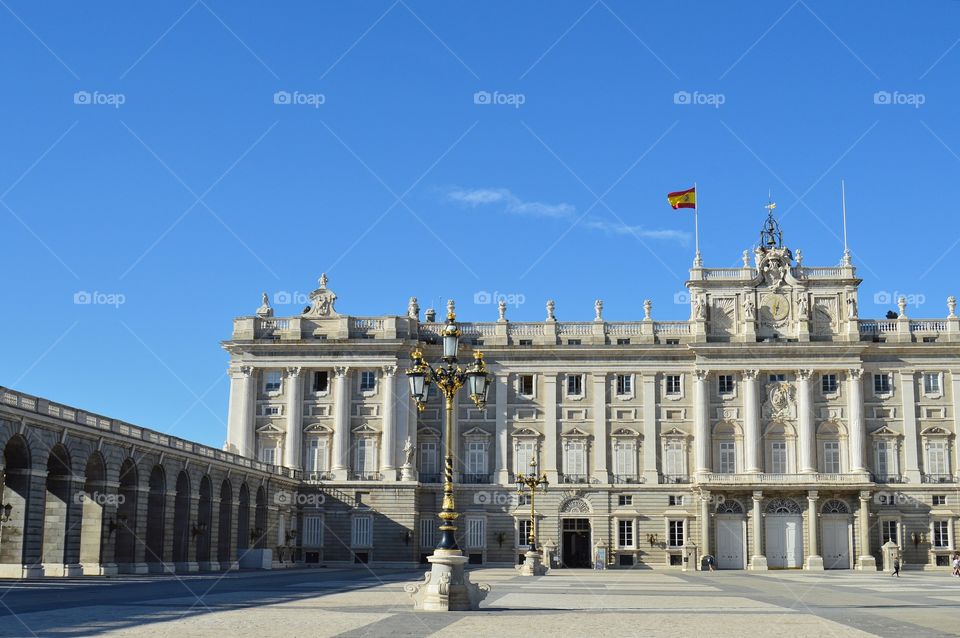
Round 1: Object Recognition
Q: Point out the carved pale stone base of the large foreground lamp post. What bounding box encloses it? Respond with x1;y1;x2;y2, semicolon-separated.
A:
403;549;490;611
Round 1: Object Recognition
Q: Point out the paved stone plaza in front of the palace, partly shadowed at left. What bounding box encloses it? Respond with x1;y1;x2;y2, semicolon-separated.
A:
0;569;960;638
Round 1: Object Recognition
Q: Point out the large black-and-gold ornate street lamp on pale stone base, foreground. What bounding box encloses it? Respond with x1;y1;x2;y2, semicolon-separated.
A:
405;300;491;611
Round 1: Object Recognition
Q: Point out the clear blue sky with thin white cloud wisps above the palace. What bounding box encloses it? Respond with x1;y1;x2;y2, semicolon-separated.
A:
0;0;960;445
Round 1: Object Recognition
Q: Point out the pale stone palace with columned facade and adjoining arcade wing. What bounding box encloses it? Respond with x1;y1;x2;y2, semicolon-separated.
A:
0;217;960;576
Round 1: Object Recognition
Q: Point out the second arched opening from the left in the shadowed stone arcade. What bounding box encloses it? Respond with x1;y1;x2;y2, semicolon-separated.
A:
41;444;74;576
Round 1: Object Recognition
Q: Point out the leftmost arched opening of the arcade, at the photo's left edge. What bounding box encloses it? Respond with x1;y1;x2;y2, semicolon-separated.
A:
0;434;30;578
